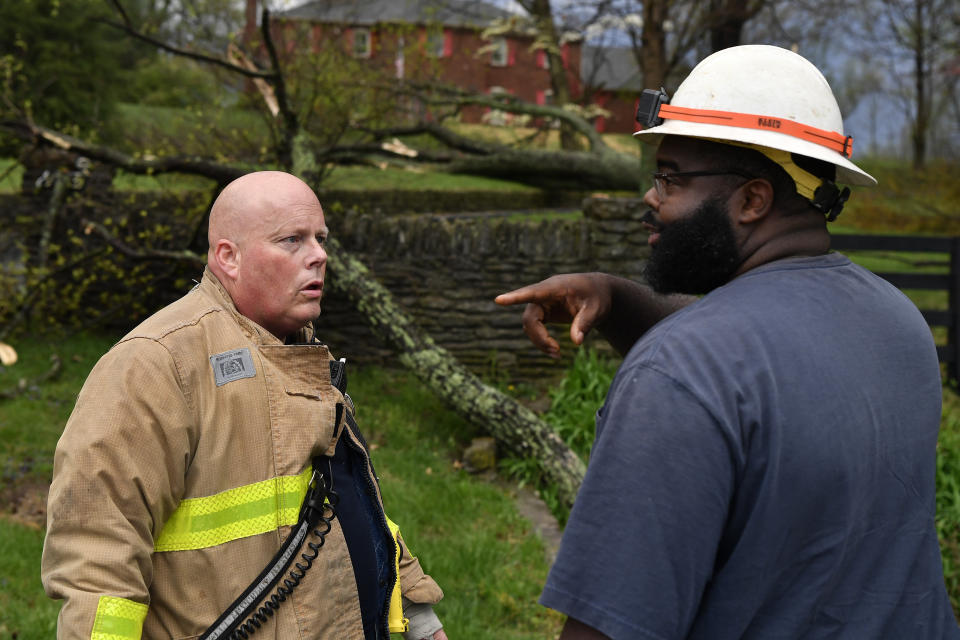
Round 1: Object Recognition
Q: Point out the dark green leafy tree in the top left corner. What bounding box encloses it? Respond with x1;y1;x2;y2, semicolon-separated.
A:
0;0;142;140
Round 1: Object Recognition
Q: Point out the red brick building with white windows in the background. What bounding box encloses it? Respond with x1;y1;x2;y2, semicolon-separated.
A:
247;0;639;132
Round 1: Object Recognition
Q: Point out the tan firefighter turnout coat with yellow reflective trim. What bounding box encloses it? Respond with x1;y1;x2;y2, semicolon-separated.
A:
42;270;442;640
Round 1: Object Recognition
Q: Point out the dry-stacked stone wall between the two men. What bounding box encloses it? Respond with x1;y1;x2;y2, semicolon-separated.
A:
321;198;648;376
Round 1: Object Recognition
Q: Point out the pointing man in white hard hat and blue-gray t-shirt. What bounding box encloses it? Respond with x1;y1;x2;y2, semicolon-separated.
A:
497;46;960;640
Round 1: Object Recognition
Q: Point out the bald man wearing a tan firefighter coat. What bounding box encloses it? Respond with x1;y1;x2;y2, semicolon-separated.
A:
41;171;446;640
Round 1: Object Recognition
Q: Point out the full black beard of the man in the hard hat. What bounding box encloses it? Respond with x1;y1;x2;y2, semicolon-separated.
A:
643;198;740;295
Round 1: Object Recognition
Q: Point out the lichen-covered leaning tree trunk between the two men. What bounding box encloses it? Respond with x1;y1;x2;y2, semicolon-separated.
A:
327;238;585;506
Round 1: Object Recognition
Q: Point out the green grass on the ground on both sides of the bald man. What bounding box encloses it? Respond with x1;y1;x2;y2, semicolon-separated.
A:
0;334;562;640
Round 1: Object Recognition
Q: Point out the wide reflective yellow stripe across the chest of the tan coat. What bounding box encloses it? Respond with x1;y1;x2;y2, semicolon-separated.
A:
153;467;312;551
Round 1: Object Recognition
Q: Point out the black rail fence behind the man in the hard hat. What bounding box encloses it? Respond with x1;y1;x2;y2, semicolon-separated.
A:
830;234;960;385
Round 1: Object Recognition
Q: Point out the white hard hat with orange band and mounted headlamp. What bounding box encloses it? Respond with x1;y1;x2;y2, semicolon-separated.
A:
634;45;877;185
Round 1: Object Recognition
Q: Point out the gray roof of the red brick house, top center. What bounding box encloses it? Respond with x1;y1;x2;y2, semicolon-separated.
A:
276;0;516;28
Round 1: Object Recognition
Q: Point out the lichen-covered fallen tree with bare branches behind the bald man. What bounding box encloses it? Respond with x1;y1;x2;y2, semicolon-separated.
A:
0;2;585;506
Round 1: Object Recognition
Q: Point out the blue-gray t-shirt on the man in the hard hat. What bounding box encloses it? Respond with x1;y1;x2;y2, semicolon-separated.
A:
540;254;960;640
